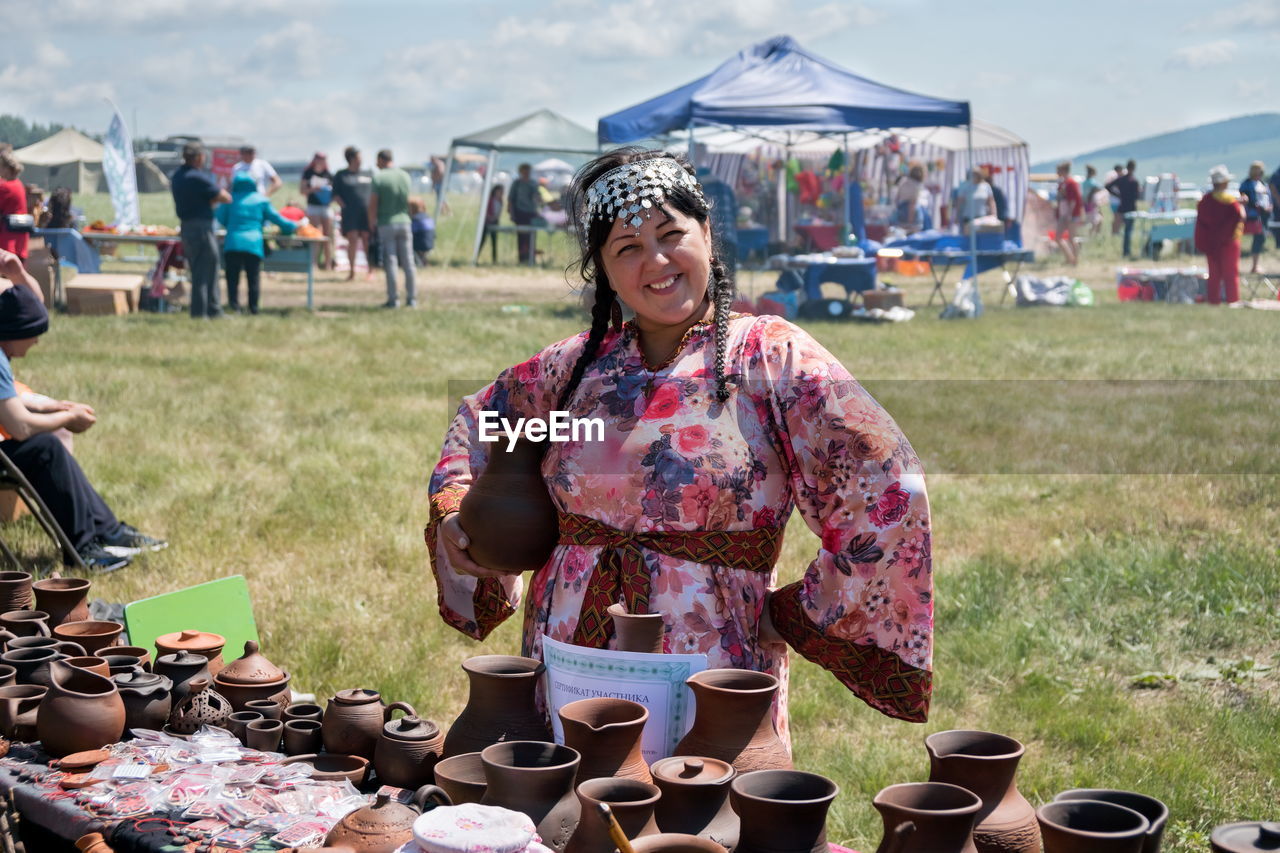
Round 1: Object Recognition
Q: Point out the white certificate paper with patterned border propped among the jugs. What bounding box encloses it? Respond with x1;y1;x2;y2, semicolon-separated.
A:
543;637;707;763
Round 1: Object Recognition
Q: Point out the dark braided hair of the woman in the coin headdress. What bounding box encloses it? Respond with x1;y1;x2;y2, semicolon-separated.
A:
558;147;733;409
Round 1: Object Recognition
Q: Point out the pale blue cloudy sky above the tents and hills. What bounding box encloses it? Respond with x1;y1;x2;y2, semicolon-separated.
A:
10;0;1280;163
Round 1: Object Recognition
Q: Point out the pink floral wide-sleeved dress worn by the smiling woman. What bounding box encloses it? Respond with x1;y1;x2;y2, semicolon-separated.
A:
426;315;933;743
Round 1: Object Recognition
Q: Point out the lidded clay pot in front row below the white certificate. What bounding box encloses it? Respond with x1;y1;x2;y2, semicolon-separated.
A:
649;756;739;849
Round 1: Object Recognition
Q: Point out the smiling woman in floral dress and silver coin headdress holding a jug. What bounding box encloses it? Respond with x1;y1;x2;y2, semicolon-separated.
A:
426;149;933;742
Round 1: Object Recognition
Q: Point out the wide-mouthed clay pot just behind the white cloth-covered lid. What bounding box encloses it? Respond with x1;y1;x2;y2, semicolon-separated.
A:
480;740;581;853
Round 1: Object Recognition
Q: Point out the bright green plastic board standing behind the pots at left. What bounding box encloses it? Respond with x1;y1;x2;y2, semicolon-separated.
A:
124;575;257;661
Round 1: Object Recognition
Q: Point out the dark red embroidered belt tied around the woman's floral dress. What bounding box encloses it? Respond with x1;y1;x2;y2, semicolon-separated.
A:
559;512;782;648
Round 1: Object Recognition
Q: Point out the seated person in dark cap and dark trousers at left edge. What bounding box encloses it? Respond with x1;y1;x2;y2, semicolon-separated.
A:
0;251;168;571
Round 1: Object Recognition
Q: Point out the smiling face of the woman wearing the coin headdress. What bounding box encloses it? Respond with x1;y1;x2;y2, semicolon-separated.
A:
600;205;712;330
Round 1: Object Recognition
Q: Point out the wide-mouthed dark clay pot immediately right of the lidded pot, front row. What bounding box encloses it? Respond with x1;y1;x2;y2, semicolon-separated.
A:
728;770;840;853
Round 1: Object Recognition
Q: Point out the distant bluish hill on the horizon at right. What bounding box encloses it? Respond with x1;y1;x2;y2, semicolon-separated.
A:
1032;113;1280;183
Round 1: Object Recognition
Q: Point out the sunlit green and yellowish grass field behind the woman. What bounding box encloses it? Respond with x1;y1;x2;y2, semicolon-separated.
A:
6;195;1280;852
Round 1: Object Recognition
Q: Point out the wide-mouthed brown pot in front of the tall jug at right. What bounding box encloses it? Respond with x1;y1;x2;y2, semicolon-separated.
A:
872;783;982;853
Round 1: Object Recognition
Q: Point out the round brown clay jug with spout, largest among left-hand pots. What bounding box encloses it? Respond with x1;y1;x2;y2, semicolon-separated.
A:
36;661;124;758
